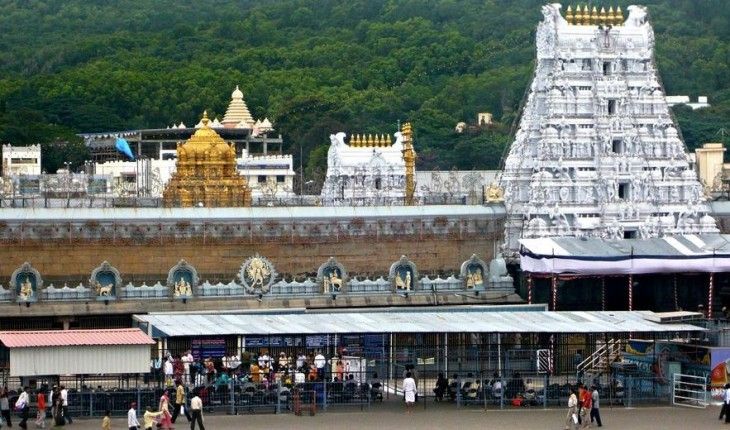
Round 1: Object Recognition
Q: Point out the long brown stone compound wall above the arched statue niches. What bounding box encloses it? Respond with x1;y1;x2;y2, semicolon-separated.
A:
0;205;504;285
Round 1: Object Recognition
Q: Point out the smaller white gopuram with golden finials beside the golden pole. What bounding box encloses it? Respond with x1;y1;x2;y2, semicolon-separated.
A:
321;132;406;206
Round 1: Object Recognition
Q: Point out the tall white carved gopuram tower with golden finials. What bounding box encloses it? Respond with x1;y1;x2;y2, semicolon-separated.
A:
500;3;718;255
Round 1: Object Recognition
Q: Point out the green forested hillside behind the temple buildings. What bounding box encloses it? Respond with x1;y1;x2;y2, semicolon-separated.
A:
0;0;730;175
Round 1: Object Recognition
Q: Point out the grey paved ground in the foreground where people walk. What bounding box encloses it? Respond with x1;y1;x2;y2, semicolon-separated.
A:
24;403;730;430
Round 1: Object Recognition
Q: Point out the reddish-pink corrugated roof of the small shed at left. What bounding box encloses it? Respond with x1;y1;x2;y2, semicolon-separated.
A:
0;328;155;348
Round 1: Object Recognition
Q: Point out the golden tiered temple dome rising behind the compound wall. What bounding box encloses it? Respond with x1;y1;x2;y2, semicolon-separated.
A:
162;112;251;207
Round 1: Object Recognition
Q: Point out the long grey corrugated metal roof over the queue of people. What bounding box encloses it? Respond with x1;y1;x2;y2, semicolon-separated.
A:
135;309;704;337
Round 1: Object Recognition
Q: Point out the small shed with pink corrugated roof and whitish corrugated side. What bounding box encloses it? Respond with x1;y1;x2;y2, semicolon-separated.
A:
0;328;155;376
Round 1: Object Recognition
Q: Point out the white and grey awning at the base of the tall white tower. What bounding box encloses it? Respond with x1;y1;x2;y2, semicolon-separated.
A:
520;234;730;275
